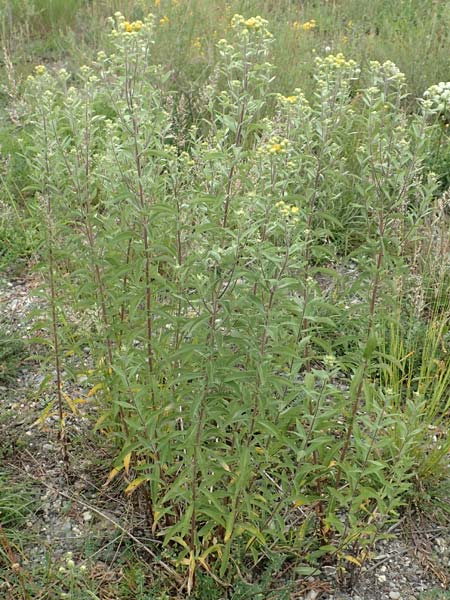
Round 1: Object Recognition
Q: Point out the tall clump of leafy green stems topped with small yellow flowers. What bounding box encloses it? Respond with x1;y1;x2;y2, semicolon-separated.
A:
19;13;450;594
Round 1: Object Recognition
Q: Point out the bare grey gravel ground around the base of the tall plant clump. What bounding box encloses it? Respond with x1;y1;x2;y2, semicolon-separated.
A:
0;277;450;600
